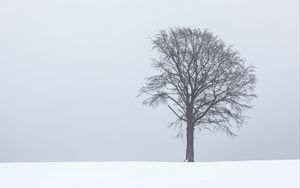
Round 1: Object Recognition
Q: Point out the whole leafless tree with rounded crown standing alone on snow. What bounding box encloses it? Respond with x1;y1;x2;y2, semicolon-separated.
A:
140;28;256;162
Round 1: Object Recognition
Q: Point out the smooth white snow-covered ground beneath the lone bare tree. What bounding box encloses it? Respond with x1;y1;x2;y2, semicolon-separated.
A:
0;160;299;188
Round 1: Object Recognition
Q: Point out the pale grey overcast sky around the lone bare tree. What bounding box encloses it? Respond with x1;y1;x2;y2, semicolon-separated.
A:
0;0;299;162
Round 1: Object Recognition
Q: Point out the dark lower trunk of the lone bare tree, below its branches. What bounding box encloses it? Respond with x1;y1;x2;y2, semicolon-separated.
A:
185;119;195;162
